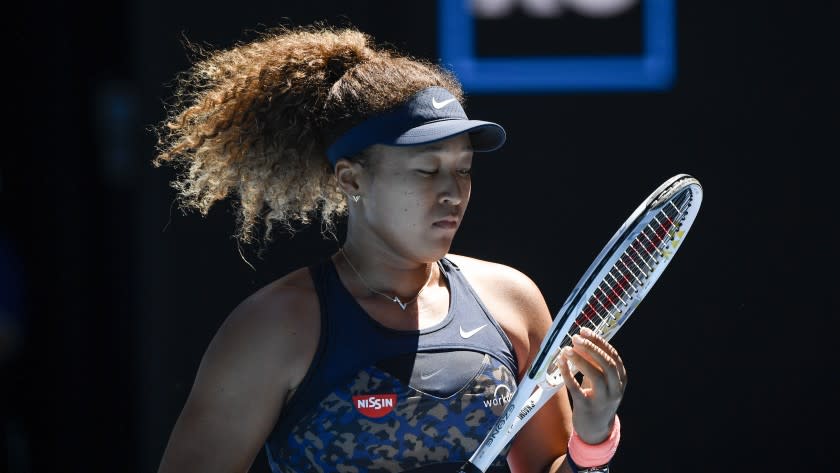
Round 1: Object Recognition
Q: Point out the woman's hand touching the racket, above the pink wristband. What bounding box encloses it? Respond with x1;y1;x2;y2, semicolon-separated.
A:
557;328;627;445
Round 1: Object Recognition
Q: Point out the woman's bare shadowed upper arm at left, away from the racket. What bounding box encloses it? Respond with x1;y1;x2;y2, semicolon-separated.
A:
158;280;319;473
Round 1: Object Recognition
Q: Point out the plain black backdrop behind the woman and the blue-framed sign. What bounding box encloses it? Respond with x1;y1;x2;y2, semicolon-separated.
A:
0;0;838;472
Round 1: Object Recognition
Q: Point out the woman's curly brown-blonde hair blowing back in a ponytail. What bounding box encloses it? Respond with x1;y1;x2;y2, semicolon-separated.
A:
152;25;463;247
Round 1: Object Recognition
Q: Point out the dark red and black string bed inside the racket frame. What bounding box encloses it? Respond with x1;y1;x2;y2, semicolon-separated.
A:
572;186;691;338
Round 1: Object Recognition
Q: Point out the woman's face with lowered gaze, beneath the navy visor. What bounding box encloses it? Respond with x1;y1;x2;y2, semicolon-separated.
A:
342;134;473;262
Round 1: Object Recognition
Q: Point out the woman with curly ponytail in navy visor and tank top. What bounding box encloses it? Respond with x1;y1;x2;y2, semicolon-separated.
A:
155;27;626;473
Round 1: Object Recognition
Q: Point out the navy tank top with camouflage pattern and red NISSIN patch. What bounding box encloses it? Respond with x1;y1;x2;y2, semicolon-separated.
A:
265;258;518;473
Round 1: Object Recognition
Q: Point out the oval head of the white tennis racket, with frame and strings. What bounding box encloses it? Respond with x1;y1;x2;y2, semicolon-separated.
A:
528;174;703;384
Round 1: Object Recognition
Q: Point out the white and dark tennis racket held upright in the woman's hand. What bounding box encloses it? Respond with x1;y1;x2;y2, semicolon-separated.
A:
459;174;703;473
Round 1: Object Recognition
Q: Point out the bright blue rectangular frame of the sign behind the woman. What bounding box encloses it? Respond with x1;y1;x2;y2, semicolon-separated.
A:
438;0;676;93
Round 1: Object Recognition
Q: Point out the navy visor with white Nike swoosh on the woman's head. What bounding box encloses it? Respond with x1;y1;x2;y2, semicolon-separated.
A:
327;87;505;166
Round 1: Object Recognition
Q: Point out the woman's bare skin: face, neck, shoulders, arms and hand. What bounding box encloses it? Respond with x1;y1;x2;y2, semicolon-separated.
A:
158;135;627;473
